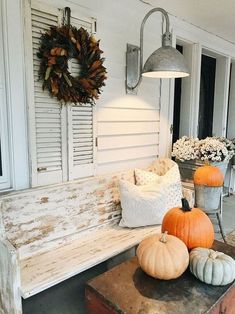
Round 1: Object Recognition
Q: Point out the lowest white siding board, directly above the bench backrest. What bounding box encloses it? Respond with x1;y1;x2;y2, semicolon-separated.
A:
97;155;158;174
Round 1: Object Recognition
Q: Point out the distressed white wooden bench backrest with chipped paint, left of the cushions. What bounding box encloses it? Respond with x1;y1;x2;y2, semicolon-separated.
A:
0;170;134;256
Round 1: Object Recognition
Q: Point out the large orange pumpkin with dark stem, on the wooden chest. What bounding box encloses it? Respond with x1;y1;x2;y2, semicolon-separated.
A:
162;199;214;249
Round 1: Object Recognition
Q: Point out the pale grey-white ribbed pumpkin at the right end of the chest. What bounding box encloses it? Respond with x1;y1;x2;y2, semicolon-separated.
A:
189;248;235;286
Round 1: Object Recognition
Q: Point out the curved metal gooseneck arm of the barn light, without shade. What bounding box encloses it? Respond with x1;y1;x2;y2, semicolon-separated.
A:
131;8;172;90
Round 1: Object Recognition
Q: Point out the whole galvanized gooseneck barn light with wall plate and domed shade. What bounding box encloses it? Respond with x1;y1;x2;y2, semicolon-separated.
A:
126;8;189;93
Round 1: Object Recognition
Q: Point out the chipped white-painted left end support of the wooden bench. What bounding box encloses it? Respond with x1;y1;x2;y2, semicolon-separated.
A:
0;240;23;314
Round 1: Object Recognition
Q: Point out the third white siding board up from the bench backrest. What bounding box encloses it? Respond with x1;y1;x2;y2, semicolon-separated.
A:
98;133;159;150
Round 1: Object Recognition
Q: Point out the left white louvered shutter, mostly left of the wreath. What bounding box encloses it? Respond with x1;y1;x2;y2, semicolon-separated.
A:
28;1;66;185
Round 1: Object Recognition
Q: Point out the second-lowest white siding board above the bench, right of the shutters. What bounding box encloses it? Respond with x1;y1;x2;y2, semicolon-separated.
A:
98;145;158;164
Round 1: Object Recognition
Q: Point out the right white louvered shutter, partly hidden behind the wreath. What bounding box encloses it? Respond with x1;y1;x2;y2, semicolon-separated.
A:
68;12;95;180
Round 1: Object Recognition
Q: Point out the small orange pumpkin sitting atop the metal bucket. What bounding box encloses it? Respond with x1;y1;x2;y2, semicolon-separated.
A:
193;165;224;186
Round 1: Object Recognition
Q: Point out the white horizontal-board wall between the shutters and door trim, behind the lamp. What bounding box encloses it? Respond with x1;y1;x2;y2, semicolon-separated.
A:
90;1;161;174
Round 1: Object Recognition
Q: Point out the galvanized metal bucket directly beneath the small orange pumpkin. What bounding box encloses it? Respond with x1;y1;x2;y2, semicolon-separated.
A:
194;184;222;212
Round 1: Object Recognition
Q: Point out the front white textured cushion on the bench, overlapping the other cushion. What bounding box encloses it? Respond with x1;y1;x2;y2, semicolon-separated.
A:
119;180;167;228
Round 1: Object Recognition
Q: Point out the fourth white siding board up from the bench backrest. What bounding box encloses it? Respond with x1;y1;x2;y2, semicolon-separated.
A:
98;121;159;136
